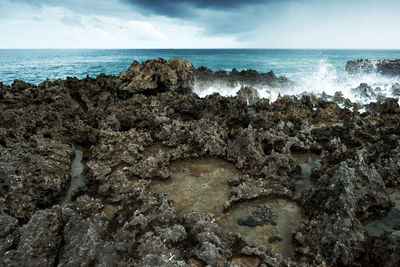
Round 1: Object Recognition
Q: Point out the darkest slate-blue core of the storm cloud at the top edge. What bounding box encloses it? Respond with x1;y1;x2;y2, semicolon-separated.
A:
120;0;268;18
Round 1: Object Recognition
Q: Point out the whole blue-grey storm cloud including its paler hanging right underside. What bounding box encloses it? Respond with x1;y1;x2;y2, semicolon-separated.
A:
119;0;290;36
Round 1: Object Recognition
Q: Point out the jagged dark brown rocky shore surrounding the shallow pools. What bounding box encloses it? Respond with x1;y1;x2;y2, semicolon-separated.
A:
0;58;400;266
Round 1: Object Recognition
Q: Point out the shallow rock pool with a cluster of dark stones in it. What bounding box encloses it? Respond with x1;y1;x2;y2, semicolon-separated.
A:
217;199;304;257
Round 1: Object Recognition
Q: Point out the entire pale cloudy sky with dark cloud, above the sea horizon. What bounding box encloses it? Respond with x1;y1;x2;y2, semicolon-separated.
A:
0;0;400;49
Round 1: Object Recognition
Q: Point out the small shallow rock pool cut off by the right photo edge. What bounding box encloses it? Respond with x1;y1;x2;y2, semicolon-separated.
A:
366;192;400;236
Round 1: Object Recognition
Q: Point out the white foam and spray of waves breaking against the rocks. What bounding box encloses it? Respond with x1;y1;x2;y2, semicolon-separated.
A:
194;60;400;107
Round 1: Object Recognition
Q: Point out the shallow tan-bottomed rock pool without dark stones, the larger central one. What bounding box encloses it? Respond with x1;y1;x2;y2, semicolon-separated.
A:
150;159;239;216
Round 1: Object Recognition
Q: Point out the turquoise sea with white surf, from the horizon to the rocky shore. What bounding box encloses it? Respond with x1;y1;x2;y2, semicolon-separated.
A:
0;49;400;103
